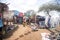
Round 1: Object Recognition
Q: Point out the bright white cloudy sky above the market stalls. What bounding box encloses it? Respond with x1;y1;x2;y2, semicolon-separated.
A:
1;0;51;12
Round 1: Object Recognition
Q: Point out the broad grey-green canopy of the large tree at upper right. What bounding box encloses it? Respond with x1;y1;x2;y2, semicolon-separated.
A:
38;0;60;14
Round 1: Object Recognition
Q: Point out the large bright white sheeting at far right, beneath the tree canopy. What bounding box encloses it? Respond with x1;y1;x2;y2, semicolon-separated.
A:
50;11;60;27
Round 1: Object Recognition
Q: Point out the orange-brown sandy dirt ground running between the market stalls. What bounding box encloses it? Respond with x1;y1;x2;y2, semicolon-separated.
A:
4;25;59;40
